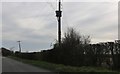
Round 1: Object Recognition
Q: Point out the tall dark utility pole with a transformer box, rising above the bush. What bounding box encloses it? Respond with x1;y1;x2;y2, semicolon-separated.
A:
56;0;62;45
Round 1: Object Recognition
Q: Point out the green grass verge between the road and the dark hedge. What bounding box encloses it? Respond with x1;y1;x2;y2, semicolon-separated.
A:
10;57;119;72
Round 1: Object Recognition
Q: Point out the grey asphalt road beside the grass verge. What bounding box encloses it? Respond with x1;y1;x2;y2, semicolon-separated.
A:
2;57;51;72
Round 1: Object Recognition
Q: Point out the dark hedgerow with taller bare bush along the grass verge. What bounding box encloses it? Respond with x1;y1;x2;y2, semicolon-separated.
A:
1;28;120;69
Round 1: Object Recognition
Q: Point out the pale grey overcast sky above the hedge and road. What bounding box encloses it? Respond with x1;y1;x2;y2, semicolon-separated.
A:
2;2;118;51
